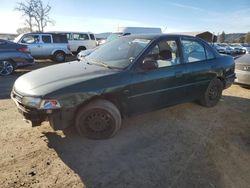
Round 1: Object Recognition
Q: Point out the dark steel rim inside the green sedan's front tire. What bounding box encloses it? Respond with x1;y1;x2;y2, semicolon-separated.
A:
84;110;114;133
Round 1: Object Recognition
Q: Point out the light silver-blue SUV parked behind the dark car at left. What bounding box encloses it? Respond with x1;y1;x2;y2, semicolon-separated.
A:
14;33;71;62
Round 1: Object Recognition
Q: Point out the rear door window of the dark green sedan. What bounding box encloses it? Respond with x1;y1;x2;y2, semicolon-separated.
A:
181;40;206;63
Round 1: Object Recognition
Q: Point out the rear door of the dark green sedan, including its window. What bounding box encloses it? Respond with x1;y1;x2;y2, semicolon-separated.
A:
181;37;216;99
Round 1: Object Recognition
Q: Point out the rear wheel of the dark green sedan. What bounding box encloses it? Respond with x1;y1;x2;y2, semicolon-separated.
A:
200;79;223;107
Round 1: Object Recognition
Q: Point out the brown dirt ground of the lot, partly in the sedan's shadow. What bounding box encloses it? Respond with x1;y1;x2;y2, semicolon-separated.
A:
0;61;250;188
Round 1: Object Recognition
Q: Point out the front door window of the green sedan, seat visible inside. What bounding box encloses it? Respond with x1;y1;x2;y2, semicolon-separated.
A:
145;40;180;68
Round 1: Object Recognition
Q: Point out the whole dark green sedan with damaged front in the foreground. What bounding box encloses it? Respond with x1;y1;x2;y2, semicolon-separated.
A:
11;35;235;139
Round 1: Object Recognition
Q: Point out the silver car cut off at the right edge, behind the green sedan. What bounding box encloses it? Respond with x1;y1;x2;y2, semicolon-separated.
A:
235;54;250;86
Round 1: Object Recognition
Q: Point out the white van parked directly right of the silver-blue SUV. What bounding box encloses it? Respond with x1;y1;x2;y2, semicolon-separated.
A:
50;32;97;53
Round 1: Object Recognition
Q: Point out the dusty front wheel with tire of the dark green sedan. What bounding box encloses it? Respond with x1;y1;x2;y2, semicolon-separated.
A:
75;99;121;139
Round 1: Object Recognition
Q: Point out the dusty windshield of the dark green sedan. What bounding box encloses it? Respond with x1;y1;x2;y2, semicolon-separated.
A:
86;37;150;69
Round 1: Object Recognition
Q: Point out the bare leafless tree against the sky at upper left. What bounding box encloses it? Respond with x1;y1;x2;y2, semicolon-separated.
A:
16;0;54;32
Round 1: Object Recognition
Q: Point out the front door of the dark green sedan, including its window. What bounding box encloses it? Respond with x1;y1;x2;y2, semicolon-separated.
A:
128;38;187;113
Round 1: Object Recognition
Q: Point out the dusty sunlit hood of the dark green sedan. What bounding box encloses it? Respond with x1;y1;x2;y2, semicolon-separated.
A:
14;61;119;96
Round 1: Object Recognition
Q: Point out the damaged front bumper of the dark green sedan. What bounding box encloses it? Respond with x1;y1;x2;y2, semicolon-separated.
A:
11;91;75;130
